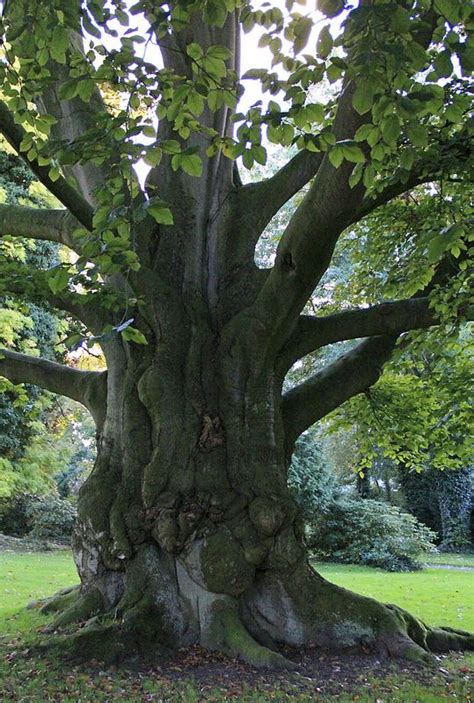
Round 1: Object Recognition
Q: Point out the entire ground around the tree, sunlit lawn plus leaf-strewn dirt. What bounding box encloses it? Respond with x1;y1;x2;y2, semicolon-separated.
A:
0;552;474;703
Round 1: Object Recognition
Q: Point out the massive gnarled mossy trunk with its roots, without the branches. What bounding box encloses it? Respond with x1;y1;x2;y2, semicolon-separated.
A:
39;164;466;665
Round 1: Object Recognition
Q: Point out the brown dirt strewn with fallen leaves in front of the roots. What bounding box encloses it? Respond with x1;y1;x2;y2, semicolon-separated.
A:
7;646;464;703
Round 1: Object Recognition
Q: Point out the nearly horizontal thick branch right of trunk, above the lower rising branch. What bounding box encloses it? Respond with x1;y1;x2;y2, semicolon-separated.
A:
282;298;437;368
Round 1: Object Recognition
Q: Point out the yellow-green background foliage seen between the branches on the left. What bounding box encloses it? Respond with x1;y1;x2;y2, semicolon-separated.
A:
0;143;93;537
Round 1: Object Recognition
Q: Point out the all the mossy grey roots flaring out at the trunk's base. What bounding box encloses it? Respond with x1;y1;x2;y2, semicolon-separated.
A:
30;560;474;668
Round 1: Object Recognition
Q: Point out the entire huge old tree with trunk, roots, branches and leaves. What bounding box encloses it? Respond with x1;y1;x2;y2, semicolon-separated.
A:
0;0;473;665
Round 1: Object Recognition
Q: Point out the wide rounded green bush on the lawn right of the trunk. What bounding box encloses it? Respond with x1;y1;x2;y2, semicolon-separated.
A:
307;498;436;571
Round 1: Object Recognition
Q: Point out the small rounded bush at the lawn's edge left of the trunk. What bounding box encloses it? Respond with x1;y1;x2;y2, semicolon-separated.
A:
27;494;77;540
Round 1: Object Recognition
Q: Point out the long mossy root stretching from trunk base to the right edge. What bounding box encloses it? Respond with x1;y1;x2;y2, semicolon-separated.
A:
243;565;474;664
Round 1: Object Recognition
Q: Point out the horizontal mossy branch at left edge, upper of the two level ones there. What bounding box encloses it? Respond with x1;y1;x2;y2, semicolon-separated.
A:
0;204;79;249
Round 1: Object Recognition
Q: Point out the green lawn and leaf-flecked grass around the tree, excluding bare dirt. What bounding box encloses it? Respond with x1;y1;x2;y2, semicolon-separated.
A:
0;552;474;703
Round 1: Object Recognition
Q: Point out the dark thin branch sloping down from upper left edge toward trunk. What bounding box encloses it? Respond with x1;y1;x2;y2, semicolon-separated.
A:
0;101;94;230
